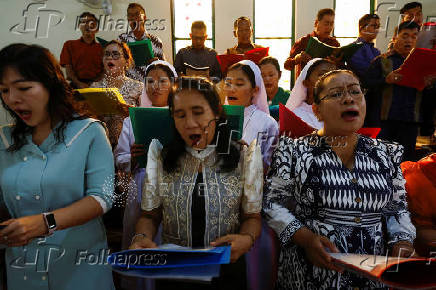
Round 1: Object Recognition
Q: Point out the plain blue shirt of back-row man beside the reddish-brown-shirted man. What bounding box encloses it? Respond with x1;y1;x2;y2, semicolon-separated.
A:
347;37;380;78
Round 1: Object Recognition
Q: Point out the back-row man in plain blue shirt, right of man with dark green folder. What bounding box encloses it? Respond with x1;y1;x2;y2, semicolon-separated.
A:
347;14;380;78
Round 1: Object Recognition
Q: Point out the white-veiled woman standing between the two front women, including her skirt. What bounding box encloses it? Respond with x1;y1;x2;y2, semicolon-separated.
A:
224;60;278;290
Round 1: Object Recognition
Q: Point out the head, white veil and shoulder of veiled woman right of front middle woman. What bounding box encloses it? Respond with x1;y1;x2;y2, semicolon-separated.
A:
224;60;278;170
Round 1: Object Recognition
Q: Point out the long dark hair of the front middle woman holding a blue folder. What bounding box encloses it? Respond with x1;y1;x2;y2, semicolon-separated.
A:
162;77;240;173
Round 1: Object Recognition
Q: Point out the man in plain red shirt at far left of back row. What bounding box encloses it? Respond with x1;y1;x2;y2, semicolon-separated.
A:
60;12;103;89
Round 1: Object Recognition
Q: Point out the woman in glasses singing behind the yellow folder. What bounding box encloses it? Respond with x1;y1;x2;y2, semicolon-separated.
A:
91;40;144;148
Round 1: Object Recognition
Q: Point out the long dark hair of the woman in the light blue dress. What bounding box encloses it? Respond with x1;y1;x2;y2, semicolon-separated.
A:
0;43;84;152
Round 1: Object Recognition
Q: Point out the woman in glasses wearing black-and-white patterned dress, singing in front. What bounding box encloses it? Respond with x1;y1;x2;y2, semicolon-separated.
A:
263;70;415;289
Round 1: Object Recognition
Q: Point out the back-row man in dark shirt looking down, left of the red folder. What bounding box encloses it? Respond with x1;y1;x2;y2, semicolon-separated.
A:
174;21;221;82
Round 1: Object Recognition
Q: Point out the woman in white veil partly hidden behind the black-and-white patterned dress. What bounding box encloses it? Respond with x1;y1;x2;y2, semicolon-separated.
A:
286;58;336;129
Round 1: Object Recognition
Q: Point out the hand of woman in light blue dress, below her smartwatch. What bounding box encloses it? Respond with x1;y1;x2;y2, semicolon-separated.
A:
0;214;48;247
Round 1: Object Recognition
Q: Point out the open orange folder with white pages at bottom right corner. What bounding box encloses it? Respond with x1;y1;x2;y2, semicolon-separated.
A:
330;253;436;289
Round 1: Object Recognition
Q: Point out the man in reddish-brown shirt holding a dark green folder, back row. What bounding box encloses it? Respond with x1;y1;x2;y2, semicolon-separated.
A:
284;8;340;77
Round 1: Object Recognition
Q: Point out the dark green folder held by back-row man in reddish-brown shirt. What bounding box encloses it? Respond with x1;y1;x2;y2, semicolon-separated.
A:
306;37;363;60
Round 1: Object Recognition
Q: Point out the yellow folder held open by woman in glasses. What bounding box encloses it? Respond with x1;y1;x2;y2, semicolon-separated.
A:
74;88;127;116
